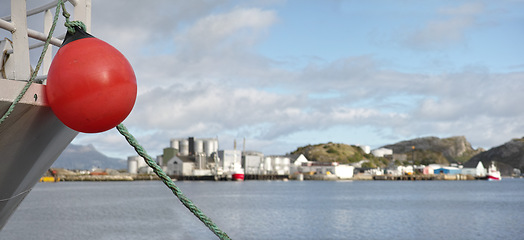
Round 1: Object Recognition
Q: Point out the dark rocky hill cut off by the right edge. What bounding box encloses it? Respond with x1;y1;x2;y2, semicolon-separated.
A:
464;138;524;176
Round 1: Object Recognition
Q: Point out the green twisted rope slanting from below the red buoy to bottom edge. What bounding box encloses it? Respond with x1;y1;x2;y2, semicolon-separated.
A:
116;124;230;239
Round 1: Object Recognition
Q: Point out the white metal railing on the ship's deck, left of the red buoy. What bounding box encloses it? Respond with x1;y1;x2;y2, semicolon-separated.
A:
0;0;91;81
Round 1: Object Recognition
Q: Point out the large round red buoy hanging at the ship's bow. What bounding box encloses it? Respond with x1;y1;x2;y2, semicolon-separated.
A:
46;28;137;133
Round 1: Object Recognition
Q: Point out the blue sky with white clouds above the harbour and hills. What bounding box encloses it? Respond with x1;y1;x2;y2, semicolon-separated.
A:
2;0;524;158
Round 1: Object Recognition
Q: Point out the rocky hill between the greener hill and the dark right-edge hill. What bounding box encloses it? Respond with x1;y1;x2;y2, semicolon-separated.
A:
383;136;484;164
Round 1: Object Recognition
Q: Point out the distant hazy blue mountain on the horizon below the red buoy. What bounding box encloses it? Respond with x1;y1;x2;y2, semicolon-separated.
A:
51;144;127;170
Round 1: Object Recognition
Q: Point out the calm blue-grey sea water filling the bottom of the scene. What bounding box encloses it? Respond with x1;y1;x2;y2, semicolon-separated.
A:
0;179;524;240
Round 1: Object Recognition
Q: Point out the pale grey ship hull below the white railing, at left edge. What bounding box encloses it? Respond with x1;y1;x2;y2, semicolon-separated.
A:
0;79;78;229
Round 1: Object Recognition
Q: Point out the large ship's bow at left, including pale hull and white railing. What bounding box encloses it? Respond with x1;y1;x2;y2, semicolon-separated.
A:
0;0;91;230
